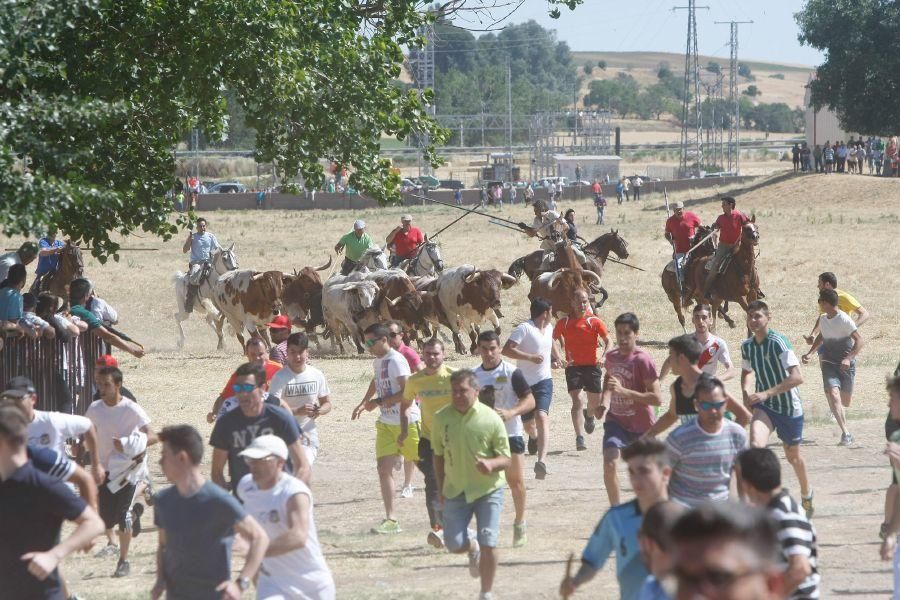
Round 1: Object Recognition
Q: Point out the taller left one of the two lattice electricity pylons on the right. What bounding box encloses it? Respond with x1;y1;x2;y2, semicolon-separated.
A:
672;0;709;177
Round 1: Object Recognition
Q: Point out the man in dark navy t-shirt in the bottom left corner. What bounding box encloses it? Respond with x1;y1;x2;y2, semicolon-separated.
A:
0;405;103;599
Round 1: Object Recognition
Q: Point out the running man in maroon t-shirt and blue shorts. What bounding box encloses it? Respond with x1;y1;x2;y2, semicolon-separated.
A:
589;313;662;506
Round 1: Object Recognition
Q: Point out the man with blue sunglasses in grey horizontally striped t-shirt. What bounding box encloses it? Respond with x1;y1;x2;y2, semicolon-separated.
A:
666;373;747;507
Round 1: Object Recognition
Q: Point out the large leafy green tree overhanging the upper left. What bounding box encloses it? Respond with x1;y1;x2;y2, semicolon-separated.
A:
0;0;579;260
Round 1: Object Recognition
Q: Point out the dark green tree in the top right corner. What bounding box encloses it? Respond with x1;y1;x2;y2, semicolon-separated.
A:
796;0;900;136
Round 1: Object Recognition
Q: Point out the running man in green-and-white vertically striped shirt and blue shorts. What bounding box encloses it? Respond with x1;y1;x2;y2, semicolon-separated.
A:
741;300;813;518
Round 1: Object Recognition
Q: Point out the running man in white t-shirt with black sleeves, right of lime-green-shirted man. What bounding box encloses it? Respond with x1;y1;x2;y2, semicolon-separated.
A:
473;330;534;548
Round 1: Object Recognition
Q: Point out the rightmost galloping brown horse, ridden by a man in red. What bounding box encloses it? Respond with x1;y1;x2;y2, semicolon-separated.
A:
686;216;764;330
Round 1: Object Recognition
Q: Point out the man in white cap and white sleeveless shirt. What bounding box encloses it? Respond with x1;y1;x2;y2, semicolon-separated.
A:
238;435;335;600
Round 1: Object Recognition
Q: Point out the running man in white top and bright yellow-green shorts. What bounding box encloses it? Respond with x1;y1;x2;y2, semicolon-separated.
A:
351;323;420;534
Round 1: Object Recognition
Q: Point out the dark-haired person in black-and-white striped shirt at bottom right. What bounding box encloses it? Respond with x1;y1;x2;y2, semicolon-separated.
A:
738;448;819;600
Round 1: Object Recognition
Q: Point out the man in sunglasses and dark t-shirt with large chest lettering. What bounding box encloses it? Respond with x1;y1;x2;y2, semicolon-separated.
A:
209;363;310;491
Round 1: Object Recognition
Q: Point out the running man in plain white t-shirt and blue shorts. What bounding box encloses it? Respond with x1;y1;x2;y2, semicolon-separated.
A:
503;298;562;479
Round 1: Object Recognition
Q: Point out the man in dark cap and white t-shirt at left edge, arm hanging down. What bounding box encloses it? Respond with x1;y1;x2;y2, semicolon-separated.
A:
2;376;106;485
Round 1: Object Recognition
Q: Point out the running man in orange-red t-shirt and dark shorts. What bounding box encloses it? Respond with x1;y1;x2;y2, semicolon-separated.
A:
553;289;609;450
